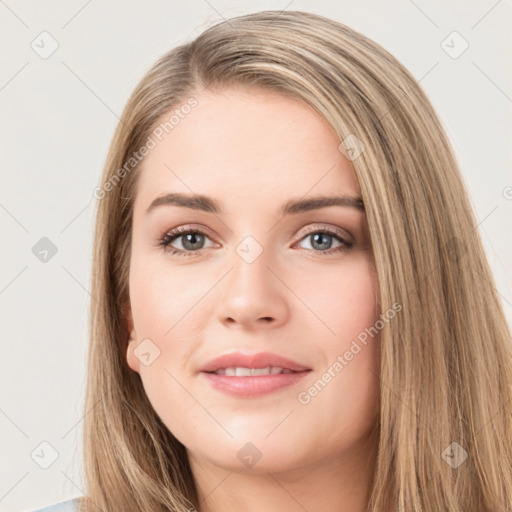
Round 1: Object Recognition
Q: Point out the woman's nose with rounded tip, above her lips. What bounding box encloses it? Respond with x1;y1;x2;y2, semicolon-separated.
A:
217;242;290;330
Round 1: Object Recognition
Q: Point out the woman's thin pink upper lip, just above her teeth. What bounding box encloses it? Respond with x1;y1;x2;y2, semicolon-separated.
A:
199;352;311;372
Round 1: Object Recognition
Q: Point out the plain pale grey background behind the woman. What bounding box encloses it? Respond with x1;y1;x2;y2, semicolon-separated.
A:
0;0;512;511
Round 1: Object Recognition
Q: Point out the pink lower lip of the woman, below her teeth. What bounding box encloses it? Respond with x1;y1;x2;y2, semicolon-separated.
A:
201;370;311;397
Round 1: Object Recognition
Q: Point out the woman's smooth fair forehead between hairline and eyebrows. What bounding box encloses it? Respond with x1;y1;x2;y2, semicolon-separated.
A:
135;88;360;214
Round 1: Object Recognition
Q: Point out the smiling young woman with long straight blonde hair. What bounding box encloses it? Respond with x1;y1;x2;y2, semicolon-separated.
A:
31;11;512;512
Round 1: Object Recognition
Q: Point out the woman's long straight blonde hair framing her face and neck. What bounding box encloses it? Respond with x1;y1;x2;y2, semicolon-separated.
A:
83;11;512;512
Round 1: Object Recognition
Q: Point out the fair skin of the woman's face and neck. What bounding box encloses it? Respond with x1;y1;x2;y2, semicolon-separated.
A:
126;88;380;512
